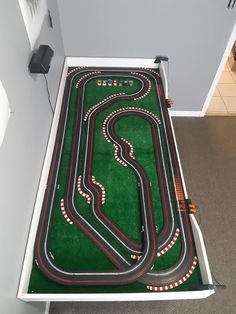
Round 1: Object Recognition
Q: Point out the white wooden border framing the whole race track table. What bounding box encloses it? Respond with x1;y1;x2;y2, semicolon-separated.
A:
17;58;214;302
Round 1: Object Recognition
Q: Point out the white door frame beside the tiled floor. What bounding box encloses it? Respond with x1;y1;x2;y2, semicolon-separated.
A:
201;22;236;117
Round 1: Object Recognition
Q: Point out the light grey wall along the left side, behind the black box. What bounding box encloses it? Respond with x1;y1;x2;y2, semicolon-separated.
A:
0;0;64;314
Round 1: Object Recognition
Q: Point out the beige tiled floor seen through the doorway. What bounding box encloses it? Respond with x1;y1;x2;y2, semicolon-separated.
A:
206;63;236;116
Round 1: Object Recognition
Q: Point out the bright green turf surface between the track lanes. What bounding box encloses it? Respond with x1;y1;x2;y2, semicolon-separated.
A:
28;67;201;293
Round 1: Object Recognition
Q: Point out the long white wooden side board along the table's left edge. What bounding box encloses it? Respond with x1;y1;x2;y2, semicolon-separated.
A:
17;60;67;299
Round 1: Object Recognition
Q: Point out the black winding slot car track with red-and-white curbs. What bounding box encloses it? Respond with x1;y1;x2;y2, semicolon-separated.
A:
34;67;197;291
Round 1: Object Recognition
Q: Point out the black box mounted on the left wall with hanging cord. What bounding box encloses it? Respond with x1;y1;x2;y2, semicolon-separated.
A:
29;45;54;73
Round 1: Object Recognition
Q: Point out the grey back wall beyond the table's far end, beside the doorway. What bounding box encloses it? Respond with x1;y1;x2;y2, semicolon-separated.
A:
58;0;236;111
